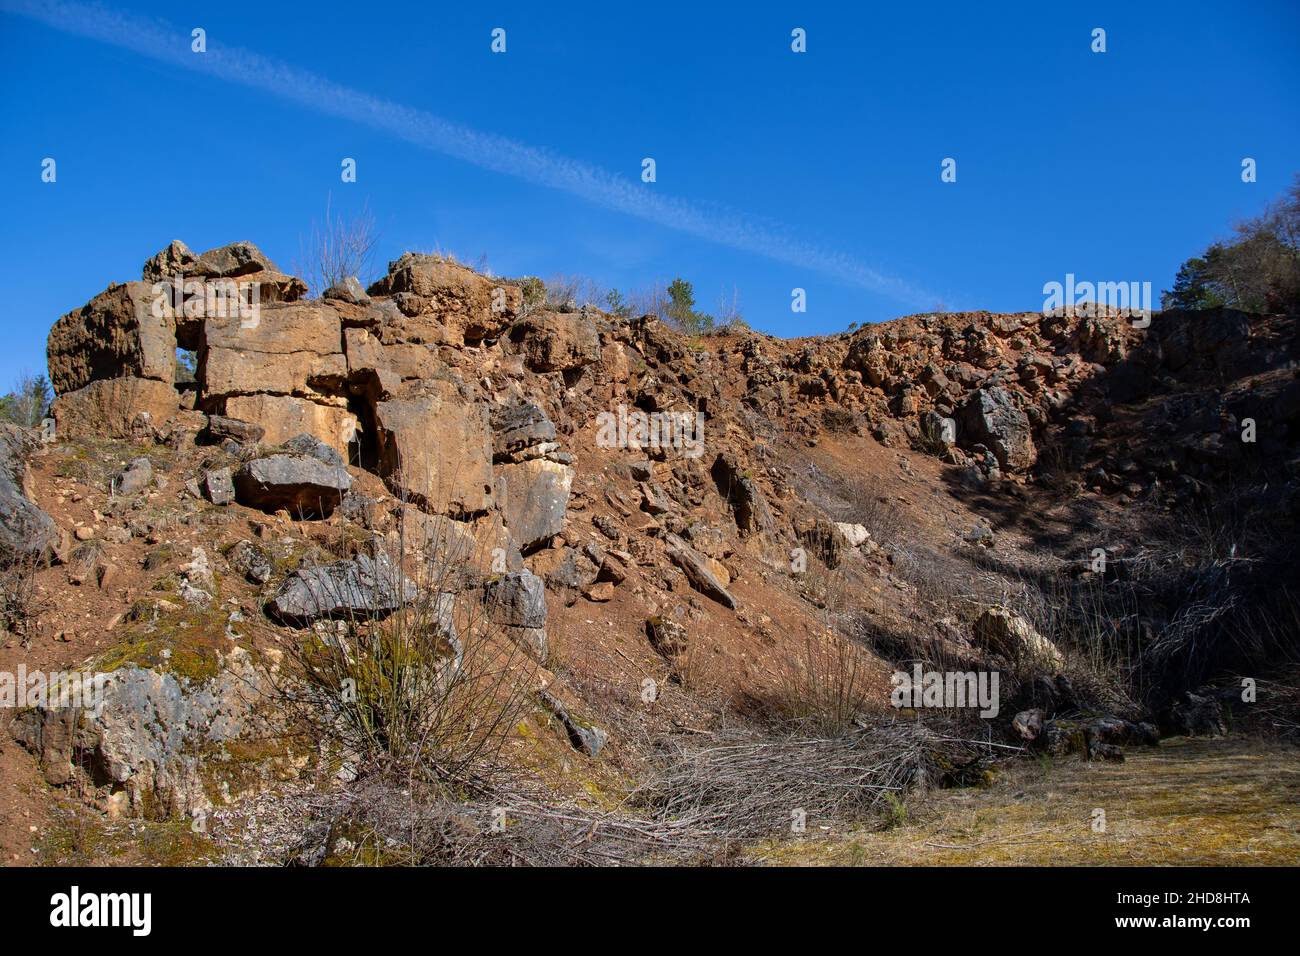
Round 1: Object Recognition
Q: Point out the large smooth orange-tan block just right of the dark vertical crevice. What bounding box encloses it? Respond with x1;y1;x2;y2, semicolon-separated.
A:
374;381;493;515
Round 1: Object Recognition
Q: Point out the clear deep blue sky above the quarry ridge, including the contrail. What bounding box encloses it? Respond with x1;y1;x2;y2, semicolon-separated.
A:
0;0;1300;386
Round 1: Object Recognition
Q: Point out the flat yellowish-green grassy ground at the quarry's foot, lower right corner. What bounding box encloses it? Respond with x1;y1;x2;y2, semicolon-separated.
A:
755;737;1300;866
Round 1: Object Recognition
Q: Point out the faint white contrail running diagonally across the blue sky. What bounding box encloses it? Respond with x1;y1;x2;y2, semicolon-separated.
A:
0;0;937;307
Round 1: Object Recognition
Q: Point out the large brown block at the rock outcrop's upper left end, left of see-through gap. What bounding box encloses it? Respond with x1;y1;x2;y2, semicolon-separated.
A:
46;282;177;395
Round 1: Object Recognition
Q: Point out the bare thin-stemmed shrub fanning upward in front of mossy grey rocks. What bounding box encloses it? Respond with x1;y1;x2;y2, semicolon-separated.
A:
274;503;536;783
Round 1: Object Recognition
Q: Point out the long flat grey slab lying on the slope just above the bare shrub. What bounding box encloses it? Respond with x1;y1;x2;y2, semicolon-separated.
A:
267;554;419;626
